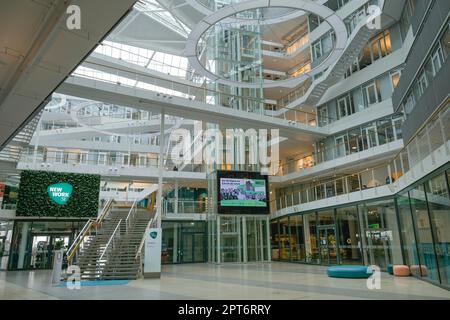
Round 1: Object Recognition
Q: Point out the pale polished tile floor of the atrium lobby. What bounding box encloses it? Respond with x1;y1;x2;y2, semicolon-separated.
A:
0;262;450;300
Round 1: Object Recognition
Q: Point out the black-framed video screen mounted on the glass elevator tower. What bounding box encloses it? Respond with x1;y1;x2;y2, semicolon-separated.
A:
217;171;269;214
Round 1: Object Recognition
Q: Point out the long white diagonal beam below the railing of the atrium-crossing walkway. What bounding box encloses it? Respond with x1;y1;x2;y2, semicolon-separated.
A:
58;76;328;143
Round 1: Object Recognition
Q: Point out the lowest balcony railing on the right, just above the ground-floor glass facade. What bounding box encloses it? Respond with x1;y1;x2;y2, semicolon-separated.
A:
272;100;450;210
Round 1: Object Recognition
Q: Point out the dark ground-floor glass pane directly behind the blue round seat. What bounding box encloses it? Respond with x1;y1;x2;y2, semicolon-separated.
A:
336;206;363;264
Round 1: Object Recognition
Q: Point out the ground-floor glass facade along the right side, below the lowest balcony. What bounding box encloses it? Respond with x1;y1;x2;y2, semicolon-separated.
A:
270;165;450;287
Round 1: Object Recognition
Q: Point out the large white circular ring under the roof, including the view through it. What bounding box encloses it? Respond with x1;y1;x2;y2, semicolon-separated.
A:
186;0;347;88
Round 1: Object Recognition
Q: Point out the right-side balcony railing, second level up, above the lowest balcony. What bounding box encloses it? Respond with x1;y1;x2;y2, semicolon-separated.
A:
278;119;402;176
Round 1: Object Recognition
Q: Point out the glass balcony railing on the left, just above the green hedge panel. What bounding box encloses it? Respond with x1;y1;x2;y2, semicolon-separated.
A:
20;149;205;172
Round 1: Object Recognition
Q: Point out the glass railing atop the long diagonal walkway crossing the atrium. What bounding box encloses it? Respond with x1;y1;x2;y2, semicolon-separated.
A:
71;63;317;127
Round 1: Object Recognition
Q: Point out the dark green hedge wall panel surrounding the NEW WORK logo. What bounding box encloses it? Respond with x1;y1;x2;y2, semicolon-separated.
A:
16;171;100;217
